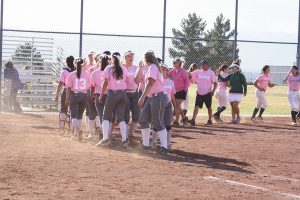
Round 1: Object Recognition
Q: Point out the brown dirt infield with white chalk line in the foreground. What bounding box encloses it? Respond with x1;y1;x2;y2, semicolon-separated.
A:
0;114;300;200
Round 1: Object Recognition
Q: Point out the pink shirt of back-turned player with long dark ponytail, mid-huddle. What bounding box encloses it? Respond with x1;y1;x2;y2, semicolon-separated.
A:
104;65;128;90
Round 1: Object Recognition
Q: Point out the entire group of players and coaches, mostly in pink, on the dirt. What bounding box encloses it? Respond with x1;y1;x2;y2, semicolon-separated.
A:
55;51;300;152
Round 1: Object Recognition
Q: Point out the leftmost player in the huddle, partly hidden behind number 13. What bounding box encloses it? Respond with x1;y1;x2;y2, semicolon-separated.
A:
55;56;75;134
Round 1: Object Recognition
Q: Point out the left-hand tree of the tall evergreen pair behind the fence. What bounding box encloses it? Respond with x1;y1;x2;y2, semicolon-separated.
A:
169;13;206;68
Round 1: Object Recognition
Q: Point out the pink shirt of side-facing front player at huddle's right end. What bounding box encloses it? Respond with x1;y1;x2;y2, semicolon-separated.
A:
146;64;164;97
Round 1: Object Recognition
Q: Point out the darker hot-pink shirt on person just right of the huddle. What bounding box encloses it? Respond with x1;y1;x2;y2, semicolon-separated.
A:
168;68;190;92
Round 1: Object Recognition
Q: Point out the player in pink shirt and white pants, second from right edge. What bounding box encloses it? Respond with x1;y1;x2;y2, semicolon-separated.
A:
251;65;274;121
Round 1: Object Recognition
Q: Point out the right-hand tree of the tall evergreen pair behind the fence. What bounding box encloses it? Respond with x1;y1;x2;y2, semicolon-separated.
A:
205;14;239;68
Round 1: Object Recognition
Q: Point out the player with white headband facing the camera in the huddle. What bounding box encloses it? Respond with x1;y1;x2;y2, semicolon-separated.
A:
124;51;140;140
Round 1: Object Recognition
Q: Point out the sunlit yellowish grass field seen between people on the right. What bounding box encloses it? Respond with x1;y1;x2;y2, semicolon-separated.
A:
188;85;291;116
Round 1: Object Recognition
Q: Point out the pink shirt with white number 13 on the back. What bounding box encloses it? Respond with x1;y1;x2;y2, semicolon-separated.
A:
67;70;91;93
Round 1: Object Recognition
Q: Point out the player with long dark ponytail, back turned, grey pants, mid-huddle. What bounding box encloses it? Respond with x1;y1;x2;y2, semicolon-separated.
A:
97;52;128;147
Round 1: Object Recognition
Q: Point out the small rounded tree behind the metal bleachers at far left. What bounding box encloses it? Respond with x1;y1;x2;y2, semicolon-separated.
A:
12;42;44;67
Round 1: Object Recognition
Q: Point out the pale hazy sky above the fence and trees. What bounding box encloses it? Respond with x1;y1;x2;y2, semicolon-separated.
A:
3;0;299;71
